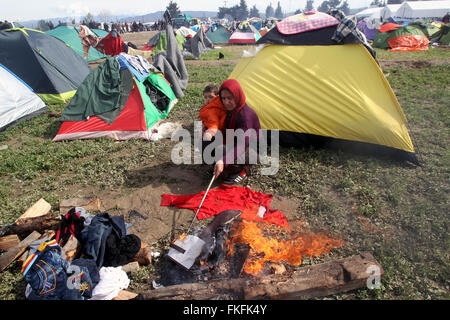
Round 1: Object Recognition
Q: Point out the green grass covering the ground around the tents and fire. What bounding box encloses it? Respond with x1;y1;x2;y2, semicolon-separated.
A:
0;47;450;300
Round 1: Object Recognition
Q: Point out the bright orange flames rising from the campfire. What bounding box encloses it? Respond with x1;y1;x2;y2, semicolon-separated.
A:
227;212;344;275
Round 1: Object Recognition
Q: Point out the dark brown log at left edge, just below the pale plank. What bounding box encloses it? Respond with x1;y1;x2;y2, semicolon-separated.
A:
0;216;61;237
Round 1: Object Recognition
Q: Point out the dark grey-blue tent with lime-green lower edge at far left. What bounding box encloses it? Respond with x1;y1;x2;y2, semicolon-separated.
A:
0;28;91;104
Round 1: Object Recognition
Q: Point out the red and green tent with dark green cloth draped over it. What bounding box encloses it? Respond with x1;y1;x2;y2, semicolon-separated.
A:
53;57;178;141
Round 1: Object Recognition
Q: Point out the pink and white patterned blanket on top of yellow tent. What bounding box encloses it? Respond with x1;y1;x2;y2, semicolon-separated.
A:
277;11;339;34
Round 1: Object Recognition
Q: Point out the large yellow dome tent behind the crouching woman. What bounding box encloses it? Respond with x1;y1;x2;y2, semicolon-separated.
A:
229;11;417;162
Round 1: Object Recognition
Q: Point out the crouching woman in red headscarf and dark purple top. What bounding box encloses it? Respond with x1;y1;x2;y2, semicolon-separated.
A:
214;79;261;185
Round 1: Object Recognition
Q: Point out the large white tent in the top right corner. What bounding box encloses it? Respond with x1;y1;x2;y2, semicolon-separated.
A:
394;0;450;19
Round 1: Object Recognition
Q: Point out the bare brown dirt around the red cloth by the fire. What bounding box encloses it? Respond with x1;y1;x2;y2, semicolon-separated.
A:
58;163;302;245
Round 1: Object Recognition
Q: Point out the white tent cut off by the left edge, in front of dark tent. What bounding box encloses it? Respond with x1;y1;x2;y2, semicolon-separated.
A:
0;64;47;131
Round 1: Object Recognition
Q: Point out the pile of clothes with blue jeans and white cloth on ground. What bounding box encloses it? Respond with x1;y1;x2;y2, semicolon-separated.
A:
21;207;141;300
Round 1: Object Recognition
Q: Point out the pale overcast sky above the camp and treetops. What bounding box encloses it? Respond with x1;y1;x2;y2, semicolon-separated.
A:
0;0;371;21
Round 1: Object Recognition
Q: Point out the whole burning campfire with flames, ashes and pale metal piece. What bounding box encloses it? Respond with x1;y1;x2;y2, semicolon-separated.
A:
159;209;344;286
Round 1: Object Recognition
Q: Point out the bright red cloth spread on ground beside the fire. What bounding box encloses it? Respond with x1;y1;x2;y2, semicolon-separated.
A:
161;184;289;227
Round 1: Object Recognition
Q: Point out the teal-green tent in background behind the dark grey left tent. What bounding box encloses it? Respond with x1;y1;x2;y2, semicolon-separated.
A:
45;26;108;61
